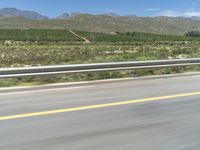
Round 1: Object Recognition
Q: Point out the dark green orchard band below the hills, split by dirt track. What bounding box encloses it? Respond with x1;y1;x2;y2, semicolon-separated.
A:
0;29;197;43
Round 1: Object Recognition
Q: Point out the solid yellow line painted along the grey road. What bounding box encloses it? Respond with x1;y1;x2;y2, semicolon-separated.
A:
0;92;200;121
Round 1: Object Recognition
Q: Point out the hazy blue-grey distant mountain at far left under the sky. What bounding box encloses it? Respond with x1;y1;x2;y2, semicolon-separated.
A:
0;8;48;20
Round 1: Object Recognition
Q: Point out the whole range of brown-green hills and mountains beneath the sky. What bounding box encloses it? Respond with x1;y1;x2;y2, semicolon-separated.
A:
0;9;200;35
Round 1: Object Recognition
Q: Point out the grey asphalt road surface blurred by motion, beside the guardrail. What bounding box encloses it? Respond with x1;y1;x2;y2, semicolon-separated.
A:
0;75;200;150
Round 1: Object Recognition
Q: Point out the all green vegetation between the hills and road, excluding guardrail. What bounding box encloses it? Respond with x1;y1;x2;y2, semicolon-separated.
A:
0;29;200;86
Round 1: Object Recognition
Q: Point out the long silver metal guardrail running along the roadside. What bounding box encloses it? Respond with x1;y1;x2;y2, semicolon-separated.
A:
0;58;200;78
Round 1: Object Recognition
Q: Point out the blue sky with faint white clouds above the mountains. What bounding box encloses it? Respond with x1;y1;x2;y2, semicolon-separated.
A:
0;0;200;17
